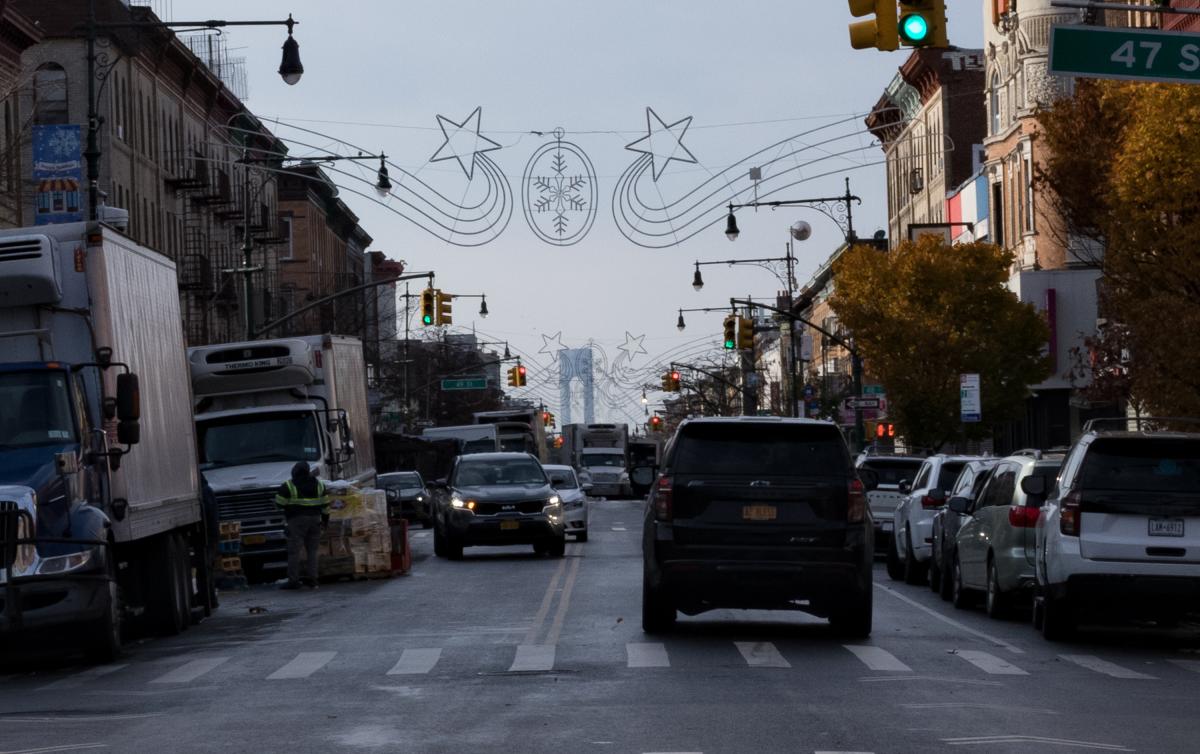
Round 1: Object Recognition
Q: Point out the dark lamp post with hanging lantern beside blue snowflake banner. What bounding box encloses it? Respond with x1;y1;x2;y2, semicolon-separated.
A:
83;0;304;220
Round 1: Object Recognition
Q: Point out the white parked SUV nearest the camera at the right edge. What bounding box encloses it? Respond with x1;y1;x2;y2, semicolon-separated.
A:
1022;418;1200;640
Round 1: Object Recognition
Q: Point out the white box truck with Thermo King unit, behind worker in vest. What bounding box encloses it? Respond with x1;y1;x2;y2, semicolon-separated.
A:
187;335;376;578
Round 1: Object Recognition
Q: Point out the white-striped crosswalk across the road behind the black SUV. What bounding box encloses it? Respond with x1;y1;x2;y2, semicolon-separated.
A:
28;641;1200;692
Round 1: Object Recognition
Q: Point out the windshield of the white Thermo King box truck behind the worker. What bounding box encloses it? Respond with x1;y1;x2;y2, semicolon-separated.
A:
196;412;320;469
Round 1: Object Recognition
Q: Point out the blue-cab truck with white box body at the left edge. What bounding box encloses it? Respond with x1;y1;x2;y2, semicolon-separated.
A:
0;222;215;659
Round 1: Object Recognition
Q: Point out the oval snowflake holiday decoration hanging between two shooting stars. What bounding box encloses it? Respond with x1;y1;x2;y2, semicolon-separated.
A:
521;128;600;246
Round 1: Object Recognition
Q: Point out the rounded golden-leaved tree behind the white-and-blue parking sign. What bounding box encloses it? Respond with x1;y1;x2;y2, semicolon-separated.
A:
830;235;1051;448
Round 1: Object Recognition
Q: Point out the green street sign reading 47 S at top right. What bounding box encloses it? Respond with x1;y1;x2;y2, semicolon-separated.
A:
1050;25;1200;84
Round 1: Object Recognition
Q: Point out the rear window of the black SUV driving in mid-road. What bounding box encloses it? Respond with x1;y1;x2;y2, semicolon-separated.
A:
671;423;851;477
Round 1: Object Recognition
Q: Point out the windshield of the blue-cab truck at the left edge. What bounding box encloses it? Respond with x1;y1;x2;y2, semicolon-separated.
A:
0;371;76;448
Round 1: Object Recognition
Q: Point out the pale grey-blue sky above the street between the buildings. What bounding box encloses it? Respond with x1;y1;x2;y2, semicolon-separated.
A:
175;0;983;423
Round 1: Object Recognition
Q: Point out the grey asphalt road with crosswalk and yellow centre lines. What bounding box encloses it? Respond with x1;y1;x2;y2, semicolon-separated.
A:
0;501;1200;754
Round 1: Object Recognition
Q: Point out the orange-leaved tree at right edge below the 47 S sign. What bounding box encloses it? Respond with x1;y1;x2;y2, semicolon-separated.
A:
1038;82;1200;415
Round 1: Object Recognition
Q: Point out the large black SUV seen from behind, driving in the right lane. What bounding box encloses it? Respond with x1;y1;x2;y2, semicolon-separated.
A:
642;417;875;636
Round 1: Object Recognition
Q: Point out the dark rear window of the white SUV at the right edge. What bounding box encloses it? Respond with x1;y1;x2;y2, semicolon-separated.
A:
1076;437;1200;493
